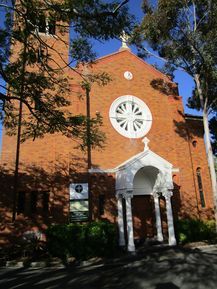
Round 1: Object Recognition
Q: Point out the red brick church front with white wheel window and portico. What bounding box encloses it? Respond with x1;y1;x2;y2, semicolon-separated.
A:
0;24;213;251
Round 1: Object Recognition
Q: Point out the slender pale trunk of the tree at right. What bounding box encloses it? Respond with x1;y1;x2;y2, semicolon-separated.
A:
194;74;217;226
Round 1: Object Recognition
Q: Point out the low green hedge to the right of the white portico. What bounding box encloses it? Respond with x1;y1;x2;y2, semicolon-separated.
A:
177;219;217;244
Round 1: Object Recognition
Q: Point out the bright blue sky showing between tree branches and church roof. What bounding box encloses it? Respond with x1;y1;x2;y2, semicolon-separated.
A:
0;0;198;150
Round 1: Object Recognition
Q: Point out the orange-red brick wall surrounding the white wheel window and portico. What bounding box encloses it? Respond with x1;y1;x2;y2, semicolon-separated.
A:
1;47;213;243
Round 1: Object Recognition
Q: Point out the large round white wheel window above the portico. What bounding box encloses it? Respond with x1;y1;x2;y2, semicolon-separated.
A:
109;95;152;138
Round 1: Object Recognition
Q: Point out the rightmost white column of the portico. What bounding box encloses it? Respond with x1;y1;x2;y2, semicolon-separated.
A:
163;190;176;246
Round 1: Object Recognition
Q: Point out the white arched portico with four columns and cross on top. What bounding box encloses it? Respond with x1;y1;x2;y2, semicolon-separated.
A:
116;138;176;252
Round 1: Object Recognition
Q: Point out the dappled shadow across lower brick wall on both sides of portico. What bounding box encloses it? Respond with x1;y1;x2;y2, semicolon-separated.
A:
0;156;212;244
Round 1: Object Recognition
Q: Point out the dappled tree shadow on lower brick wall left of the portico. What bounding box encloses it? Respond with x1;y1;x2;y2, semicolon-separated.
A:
0;156;117;244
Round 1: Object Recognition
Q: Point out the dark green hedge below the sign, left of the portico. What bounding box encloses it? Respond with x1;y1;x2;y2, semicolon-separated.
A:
46;221;117;260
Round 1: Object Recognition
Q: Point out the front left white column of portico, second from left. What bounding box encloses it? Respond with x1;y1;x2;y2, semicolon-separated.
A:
124;192;135;252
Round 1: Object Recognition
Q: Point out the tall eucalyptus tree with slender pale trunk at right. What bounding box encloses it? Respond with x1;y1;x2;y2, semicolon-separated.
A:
133;0;217;221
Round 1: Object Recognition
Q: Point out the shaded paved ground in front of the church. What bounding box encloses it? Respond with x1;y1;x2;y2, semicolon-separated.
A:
0;247;217;289
